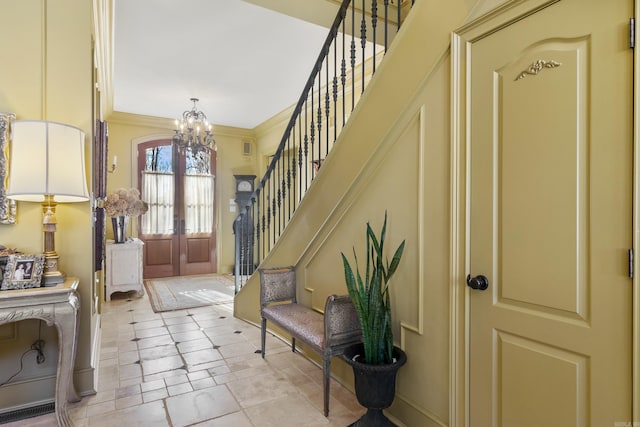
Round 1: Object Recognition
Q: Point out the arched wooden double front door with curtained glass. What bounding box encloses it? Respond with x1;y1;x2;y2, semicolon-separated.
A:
138;140;217;278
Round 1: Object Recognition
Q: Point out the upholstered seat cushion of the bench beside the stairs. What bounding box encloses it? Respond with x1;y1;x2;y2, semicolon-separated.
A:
262;304;325;353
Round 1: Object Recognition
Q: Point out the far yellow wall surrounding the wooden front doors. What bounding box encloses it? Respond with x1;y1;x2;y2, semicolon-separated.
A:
106;113;258;273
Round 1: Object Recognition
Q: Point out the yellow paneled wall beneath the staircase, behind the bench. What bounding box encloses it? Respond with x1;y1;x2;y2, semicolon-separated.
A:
235;0;484;426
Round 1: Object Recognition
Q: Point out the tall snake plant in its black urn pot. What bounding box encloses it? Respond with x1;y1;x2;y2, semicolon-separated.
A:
341;212;407;427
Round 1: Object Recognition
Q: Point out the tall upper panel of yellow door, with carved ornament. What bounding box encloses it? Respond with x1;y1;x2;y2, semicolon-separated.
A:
492;45;589;320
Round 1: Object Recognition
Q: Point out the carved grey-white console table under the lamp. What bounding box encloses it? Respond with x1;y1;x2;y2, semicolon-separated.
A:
0;277;80;426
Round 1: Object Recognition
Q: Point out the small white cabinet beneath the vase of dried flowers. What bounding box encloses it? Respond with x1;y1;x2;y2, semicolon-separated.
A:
105;238;144;301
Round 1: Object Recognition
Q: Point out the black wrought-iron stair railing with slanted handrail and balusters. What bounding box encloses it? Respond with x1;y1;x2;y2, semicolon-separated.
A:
234;0;413;293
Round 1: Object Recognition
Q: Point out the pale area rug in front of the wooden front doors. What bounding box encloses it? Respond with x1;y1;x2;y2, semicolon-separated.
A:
144;274;235;313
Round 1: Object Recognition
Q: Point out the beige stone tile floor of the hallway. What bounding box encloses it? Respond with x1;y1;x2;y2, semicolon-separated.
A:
5;294;364;427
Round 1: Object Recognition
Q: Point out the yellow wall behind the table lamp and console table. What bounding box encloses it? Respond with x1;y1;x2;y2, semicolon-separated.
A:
0;0;98;410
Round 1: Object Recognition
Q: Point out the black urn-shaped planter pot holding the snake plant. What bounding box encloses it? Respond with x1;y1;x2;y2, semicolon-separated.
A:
342;344;407;427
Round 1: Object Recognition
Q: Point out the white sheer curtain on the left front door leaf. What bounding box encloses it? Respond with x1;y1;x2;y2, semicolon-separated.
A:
141;171;175;234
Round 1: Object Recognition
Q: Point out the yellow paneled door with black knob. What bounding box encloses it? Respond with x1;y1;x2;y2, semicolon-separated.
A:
466;0;633;427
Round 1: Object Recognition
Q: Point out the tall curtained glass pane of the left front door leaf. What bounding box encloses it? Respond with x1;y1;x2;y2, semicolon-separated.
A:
141;145;175;234
